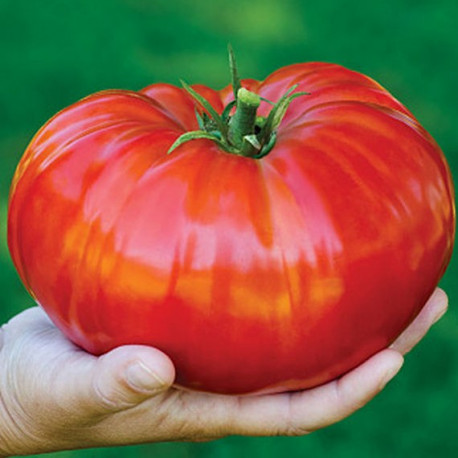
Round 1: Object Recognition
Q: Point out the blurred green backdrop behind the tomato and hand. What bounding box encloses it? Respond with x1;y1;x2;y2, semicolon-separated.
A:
0;0;458;458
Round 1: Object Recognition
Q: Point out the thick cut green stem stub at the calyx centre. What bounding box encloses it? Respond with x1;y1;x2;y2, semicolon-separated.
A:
228;87;261;153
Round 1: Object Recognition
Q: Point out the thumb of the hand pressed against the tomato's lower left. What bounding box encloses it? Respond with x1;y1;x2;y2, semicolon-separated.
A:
83;345;175;414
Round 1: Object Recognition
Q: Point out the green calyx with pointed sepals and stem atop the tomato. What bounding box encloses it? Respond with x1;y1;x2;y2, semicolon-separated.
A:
167;46;308;159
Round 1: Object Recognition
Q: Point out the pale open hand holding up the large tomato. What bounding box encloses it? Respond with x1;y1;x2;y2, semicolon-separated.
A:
0;289;448;456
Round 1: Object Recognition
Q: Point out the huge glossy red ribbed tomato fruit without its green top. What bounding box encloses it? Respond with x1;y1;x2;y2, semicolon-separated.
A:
8;63;455;394
